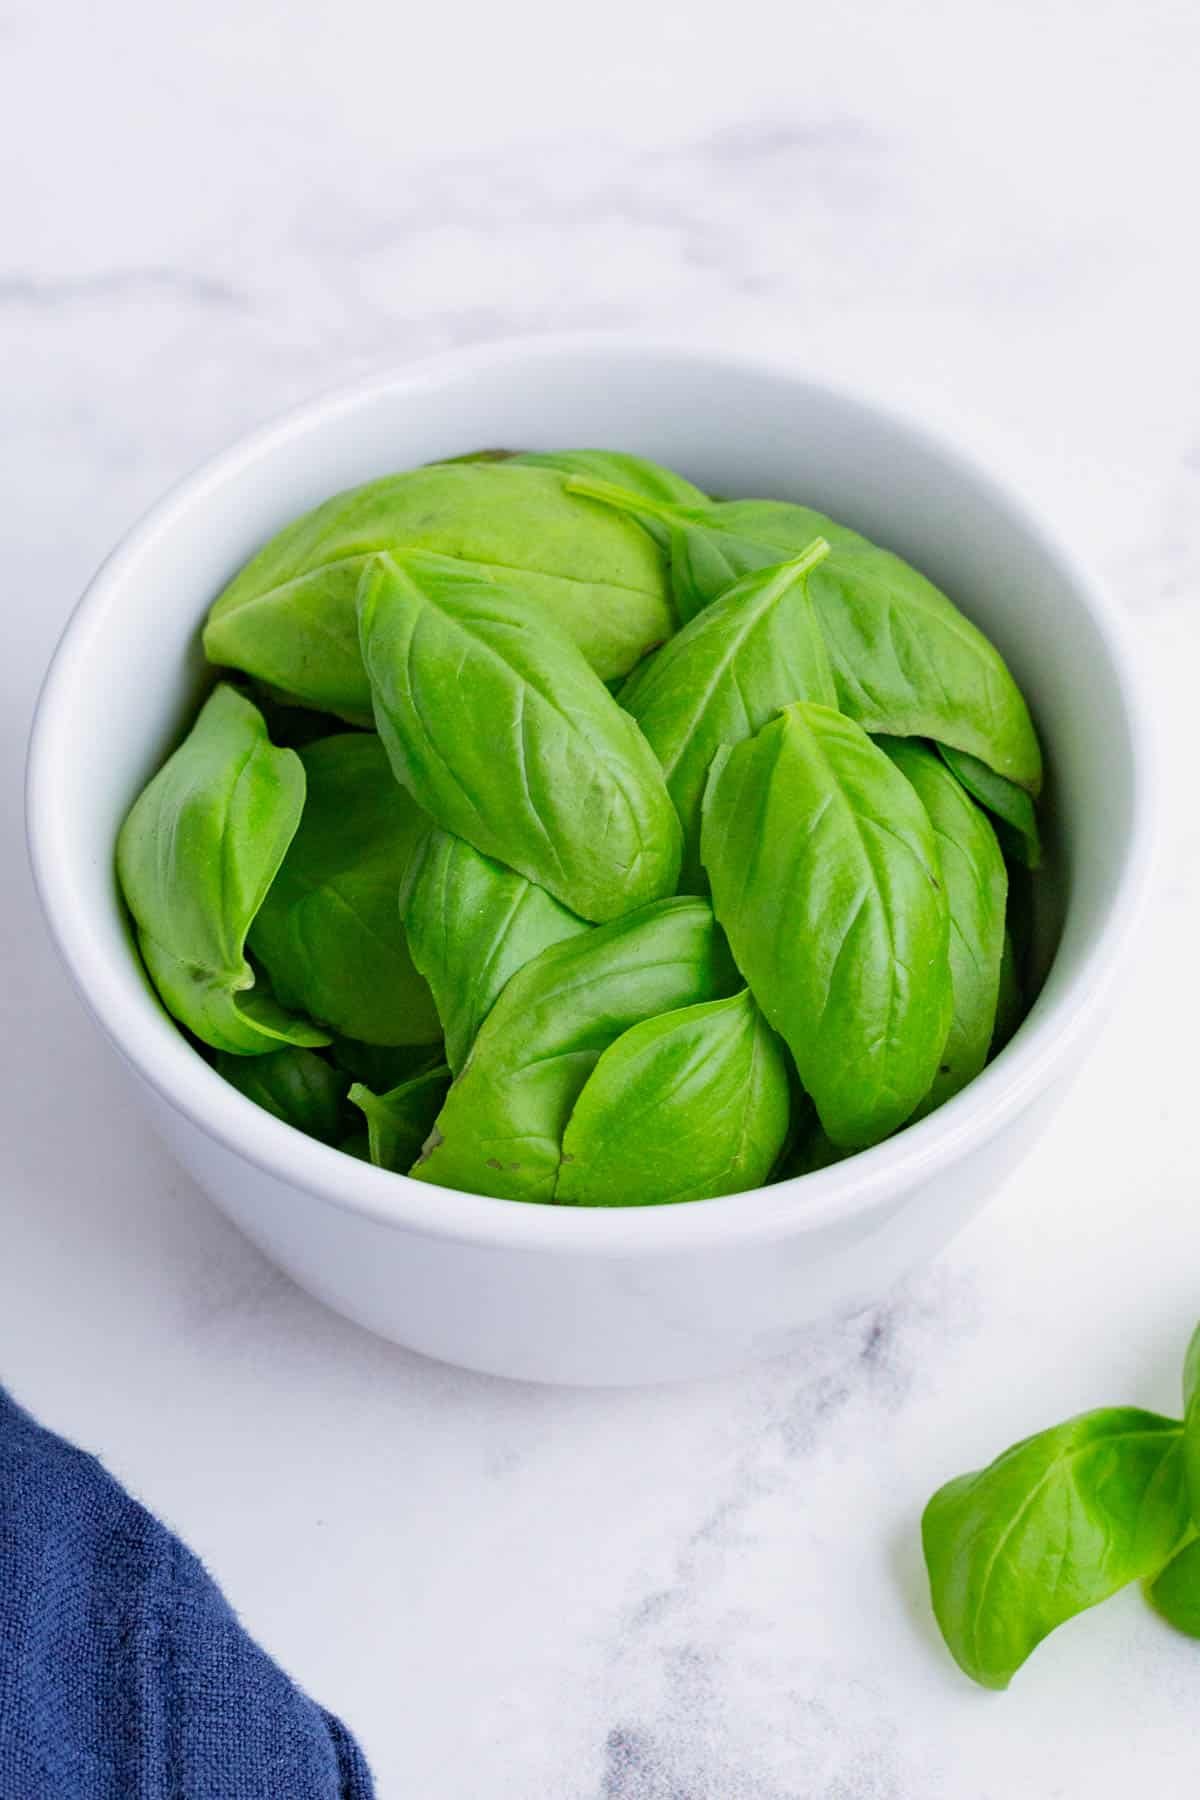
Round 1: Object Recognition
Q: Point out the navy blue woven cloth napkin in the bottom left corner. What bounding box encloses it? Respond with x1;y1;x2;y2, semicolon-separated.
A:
0;1390;372;1800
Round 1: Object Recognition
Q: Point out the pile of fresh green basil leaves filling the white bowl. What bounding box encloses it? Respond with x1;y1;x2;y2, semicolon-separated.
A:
117;452;1042;1206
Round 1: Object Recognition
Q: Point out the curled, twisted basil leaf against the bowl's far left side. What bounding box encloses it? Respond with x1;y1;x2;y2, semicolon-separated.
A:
117;684;327;1057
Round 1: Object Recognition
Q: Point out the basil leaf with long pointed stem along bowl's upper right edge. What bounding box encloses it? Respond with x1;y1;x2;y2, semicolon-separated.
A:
569;477;1042;794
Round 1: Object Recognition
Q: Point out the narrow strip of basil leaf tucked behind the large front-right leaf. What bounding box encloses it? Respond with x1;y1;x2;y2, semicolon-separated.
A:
878;738;1020;1118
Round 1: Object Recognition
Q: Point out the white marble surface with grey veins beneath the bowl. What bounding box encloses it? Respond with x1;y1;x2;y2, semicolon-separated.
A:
0;0;1200;1800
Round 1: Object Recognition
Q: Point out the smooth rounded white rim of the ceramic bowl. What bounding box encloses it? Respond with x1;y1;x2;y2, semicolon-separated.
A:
25;331;1157;1258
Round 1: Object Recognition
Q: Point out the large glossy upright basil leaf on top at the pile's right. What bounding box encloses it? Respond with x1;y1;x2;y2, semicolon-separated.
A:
702;702;952;1148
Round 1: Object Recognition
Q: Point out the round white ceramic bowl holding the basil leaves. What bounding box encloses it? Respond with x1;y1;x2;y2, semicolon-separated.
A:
29;338;1150;1384
